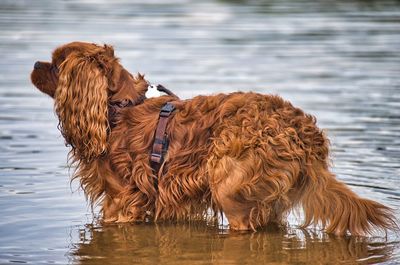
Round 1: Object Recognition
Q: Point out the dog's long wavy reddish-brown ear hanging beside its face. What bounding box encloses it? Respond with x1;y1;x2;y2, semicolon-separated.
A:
55;47;110;161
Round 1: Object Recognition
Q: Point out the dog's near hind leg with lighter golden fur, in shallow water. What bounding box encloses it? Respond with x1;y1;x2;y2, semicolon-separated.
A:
208;152;291;230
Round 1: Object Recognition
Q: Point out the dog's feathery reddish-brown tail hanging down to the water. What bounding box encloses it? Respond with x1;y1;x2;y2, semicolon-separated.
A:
299;162;399;235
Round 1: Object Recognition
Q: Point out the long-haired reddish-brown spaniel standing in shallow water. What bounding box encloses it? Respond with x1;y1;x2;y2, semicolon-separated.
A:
31;42;396;235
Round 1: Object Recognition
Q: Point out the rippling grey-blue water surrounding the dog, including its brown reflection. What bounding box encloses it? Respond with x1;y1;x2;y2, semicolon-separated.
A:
0;0;400;264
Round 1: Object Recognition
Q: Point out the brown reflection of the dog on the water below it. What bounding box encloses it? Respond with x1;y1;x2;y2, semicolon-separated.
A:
70;223;394;264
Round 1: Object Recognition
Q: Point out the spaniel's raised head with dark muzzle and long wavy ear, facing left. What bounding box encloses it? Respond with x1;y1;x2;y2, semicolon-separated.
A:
31;42;147;161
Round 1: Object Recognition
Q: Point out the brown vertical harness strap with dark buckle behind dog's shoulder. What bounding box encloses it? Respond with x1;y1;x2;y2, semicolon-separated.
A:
150;102;175;174
